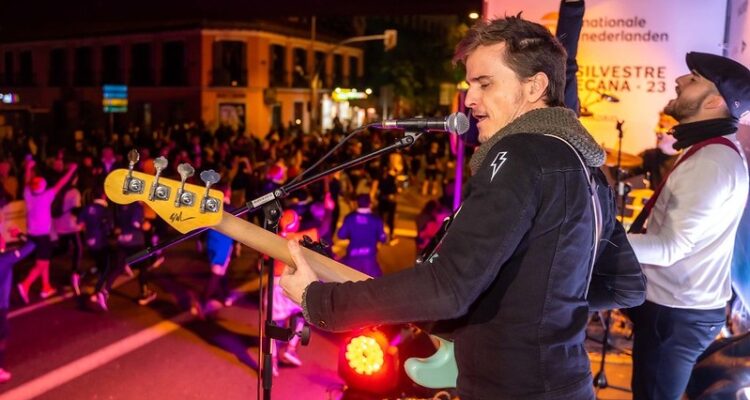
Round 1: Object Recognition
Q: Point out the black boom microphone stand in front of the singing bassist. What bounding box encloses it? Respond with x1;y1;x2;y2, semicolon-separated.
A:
126;126;424;400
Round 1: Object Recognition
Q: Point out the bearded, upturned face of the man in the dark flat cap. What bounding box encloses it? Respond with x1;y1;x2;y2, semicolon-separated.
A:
664;71;718;123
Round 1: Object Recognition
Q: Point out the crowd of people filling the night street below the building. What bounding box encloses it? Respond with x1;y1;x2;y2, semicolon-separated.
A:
0;111;458;380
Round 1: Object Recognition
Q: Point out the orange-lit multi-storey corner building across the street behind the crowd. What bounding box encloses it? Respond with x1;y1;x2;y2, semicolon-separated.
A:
0;22;364;142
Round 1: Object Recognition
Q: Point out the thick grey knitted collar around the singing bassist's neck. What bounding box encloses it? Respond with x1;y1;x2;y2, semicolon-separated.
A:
469;107;607;174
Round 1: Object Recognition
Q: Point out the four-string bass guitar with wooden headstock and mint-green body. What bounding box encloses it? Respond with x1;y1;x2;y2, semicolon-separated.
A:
104;154;458;388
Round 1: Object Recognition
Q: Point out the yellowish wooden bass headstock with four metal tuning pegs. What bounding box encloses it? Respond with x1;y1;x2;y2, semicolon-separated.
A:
104;157;224;233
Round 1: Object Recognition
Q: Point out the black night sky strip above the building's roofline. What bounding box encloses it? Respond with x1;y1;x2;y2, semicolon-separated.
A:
0;0;482;42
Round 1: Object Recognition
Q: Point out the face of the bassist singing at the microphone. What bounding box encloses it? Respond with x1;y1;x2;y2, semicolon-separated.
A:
465;43;528;143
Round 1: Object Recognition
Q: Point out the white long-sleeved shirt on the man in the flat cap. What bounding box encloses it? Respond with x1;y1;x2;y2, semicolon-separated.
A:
628;135;748;310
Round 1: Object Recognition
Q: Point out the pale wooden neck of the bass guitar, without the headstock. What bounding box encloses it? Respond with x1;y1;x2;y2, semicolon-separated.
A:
212;211;370;282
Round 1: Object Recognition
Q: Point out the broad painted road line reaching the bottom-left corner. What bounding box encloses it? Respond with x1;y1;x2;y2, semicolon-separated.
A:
0;312;192;400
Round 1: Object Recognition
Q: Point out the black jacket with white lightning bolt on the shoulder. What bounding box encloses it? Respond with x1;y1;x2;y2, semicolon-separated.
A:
305;130;645;400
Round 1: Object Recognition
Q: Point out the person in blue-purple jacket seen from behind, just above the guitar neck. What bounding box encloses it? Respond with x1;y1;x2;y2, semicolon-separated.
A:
338;194;387;277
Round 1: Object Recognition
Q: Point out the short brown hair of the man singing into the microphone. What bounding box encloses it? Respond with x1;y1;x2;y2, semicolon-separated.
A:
453;13;567;107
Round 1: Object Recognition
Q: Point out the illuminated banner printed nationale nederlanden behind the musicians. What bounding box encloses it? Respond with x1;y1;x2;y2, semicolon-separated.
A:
484;0;726;154
